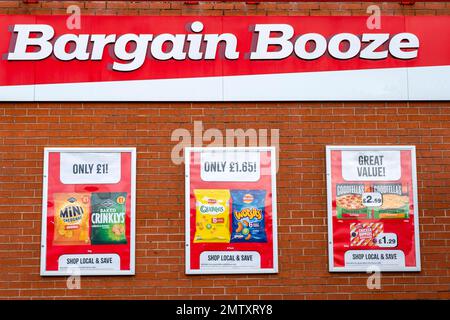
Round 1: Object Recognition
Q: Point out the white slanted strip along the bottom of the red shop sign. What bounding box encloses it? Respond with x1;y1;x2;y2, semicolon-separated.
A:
0;66;450;102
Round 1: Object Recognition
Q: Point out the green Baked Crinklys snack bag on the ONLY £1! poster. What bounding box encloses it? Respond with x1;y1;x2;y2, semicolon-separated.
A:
91;192;127;244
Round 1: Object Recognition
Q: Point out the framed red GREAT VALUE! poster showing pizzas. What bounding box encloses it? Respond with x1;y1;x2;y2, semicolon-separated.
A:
326;146;420;272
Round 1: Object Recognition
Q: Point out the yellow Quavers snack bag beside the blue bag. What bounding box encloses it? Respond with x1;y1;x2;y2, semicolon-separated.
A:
194;189;230;243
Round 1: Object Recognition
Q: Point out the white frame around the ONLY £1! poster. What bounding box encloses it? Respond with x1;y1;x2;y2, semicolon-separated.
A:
40;147;136;276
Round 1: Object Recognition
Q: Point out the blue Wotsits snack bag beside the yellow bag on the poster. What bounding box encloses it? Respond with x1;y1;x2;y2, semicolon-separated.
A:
231;190;267;242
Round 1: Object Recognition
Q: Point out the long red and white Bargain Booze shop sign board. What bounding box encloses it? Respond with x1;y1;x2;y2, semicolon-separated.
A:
0;15;450;101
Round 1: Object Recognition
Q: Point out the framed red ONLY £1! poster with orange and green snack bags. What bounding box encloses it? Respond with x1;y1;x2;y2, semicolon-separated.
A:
41;148;136;276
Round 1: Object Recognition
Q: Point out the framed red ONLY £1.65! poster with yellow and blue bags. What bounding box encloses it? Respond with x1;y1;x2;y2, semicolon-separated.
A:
185;147;278;274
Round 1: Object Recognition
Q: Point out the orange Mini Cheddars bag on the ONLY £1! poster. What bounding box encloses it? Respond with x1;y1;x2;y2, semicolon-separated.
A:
53;193;90;245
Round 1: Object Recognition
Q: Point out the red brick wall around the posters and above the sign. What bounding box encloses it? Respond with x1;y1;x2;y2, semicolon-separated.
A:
0;1;450;299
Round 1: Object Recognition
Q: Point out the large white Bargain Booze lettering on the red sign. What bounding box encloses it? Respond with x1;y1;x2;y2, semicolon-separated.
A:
7;21;419;71
